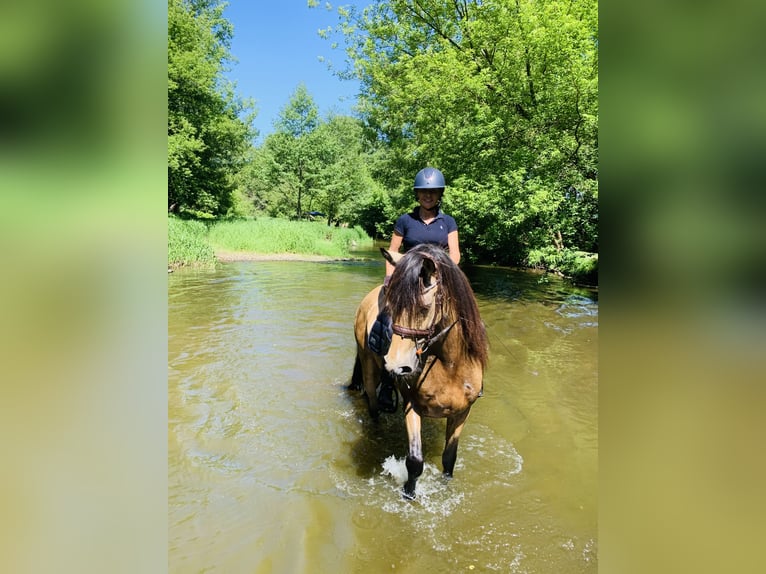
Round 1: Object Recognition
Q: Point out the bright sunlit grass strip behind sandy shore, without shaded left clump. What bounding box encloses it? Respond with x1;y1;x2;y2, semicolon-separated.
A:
208;217;372;257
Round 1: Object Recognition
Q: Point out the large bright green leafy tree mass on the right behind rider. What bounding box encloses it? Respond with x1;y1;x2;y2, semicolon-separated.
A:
320;0;598;263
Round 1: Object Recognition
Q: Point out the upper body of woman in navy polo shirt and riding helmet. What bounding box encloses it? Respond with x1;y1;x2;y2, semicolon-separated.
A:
383;167;460;285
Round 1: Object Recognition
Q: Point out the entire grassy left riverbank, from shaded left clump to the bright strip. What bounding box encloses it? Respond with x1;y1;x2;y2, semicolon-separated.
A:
168;217;372;267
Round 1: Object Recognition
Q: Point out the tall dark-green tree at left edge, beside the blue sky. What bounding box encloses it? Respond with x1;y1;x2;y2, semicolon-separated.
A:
168;0;254;217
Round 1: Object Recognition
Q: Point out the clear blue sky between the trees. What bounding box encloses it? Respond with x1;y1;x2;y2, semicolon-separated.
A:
224;0;367;142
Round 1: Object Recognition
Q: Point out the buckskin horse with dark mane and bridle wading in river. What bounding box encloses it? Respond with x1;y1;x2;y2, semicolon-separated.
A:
351;244;489;499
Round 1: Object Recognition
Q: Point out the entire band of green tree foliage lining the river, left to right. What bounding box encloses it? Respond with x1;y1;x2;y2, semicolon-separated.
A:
168;0;598;280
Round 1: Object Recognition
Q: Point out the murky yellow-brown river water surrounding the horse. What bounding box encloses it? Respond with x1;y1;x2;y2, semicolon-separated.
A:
168;259;598;574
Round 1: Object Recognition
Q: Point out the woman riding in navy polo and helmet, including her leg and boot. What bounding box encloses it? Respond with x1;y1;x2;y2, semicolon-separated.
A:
368;167;460;412
